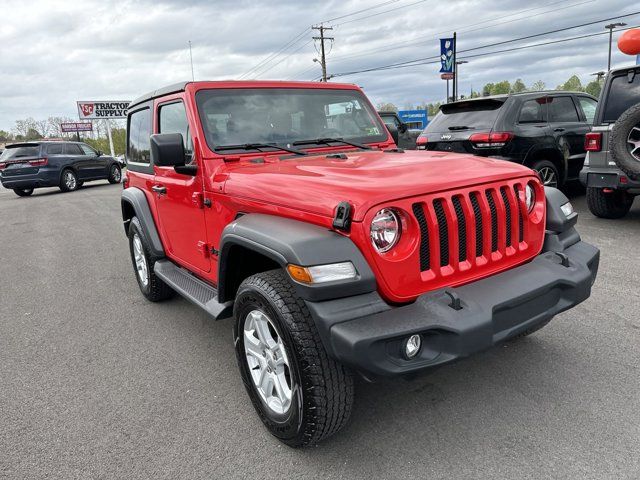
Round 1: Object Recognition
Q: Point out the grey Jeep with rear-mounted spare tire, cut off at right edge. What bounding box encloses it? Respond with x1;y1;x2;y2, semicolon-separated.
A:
580;66;640;218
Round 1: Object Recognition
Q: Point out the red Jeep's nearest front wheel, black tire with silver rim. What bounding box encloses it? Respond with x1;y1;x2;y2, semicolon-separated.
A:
234;270;354;447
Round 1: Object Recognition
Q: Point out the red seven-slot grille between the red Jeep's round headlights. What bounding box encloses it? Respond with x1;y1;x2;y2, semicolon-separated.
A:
412;183;527;272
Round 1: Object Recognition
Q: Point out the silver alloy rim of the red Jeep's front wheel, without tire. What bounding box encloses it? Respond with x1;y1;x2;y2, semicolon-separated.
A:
244;310;293;415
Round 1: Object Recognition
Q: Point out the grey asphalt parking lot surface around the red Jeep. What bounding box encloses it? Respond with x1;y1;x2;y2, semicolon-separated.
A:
0;182;640;479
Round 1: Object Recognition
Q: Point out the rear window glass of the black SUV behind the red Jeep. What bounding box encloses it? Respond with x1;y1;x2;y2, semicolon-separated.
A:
425;99;504;132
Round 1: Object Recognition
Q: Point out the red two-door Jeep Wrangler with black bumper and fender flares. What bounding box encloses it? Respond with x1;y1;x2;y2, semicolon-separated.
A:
122;81;599;446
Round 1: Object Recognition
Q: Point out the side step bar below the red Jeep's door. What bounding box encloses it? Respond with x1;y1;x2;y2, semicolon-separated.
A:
153;260;233;320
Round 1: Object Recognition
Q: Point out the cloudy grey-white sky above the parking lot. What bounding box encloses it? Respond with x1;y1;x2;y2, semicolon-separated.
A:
0;0;640;130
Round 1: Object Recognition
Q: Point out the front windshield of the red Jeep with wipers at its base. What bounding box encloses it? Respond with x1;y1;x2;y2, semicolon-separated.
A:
196;88;387;150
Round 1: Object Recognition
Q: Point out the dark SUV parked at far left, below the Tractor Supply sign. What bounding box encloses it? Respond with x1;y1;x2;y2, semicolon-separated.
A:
0;141;122;197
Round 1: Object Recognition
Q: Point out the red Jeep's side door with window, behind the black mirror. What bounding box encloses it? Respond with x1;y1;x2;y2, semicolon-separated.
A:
152;100;211;272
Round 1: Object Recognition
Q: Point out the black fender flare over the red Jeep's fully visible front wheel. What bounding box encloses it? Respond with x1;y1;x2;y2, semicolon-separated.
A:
218;213;376;302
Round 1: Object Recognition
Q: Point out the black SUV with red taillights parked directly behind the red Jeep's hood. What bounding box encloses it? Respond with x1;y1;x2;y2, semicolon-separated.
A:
418;91;597;187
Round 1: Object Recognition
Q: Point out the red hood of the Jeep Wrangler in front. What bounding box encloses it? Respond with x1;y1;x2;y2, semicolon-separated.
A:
218;150;531;221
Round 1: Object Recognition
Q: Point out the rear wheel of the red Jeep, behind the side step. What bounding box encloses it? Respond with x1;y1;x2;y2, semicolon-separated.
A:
129;217;174;302
